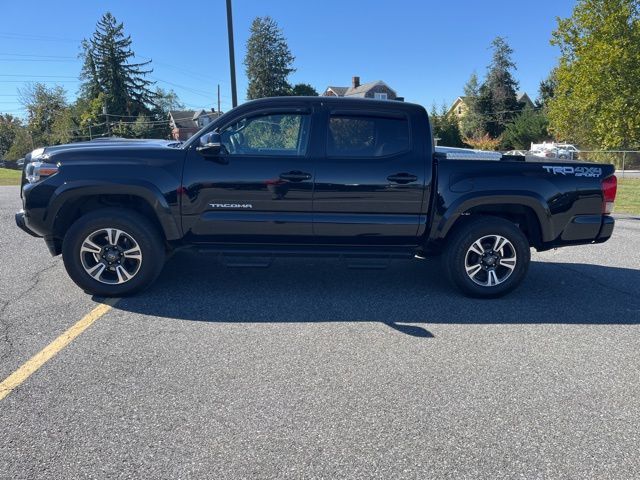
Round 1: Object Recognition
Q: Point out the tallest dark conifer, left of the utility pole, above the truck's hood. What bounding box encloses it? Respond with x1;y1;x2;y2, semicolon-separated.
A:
81;12;155;116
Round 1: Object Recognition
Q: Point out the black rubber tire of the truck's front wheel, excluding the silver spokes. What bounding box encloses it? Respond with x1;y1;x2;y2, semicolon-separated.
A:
62;208;165;297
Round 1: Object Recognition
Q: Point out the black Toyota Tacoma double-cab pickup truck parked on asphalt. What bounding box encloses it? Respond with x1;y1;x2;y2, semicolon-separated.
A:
16;97;616;297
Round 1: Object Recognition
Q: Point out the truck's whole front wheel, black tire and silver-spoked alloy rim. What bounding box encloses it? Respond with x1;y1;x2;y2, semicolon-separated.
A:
62;208;165;297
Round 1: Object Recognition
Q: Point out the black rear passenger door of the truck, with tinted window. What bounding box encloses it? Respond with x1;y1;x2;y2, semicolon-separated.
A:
313;104;425;245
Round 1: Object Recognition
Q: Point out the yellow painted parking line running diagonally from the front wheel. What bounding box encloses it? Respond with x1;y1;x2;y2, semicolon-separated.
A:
0;298;118;400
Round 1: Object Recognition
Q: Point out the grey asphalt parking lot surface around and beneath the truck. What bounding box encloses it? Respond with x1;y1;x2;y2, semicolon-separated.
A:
0;187;640;479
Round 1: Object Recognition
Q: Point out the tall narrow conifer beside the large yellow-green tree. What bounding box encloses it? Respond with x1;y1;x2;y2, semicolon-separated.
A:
478;37;522;138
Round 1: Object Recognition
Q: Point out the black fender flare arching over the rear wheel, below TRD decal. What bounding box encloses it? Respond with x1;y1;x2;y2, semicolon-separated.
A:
431;191;555;241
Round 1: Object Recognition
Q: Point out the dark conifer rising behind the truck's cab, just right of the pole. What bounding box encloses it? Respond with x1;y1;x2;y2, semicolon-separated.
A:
244;17;295;99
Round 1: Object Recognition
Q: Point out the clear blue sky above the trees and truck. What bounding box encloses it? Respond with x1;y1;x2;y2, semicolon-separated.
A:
0;0;575;115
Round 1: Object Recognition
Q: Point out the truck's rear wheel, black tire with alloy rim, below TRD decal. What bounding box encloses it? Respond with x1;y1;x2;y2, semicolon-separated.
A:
442;216;531;298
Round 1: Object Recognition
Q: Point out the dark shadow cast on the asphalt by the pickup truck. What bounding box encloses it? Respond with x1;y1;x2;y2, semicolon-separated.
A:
105;251;640;338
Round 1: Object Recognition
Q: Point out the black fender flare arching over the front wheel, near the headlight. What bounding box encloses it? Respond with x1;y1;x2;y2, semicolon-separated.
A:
44;179;182;240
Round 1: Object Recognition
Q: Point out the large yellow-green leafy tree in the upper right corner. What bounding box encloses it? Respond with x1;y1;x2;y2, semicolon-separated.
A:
548;0;640;149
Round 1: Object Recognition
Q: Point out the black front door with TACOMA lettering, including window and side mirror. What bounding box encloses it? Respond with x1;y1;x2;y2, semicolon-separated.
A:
182;108;313;243
